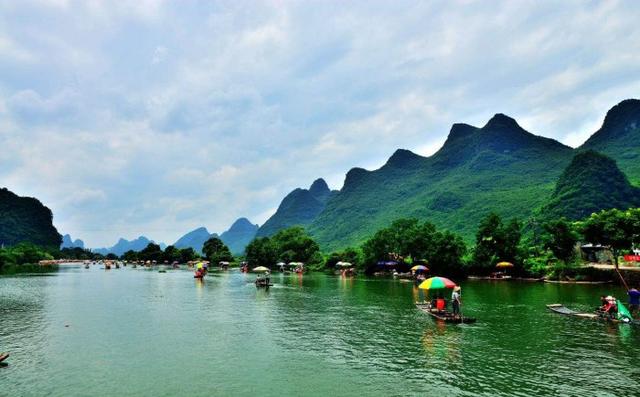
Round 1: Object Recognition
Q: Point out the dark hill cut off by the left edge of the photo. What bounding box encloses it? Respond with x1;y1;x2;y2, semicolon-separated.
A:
0;188;62;248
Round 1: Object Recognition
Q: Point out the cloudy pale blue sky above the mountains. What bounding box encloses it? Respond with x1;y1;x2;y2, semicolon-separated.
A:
0;0;640;247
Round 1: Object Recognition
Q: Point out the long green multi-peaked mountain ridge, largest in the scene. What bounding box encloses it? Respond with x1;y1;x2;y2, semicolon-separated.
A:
308;116;574;252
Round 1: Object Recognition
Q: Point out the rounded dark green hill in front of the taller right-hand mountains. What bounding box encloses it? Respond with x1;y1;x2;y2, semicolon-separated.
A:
542;150;640;220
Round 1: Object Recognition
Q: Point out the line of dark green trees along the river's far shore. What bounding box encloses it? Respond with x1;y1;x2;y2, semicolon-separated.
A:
0;208;640;281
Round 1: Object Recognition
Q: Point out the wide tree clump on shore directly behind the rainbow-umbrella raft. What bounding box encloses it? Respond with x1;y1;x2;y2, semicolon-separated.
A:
362;218;466;274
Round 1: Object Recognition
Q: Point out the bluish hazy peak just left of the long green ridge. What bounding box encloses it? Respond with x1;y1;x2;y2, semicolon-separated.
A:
256;178;331;237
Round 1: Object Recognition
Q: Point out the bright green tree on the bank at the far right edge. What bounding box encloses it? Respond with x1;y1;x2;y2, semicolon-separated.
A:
579;208;640;270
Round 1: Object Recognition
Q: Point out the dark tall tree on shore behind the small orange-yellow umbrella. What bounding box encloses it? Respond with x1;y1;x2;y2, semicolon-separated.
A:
473;213;522;268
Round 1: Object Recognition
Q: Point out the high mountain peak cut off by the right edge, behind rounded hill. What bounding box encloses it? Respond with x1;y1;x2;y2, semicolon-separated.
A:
580;99;640;185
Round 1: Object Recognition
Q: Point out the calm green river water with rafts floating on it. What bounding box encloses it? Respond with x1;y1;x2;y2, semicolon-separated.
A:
0;266;640;396
